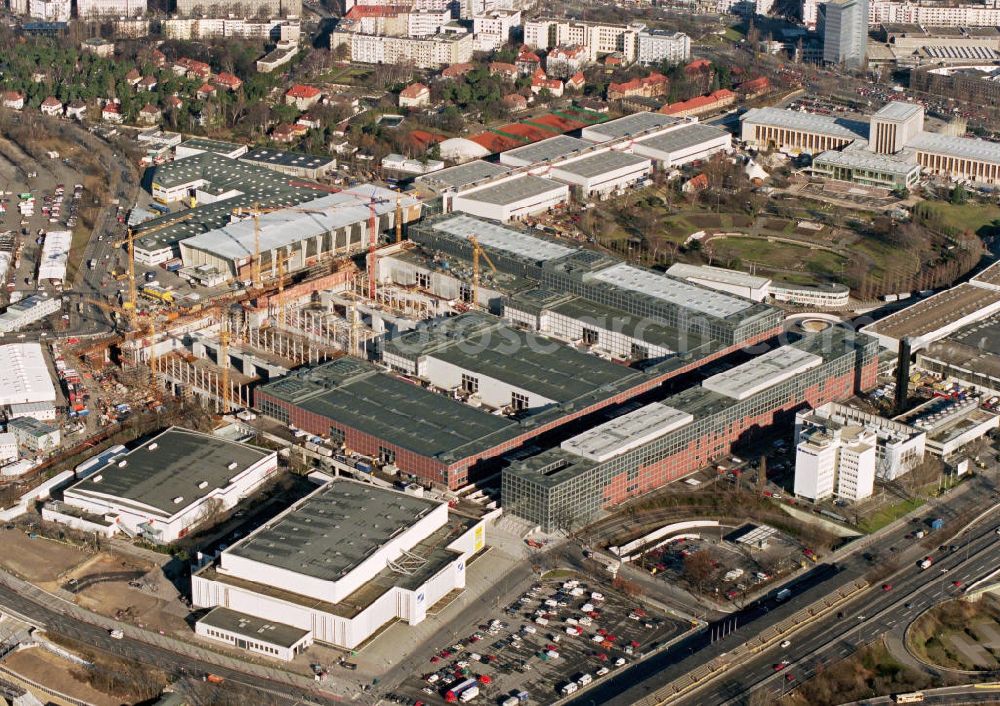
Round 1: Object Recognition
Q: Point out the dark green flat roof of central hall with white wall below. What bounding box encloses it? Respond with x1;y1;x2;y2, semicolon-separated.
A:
384;313;642;403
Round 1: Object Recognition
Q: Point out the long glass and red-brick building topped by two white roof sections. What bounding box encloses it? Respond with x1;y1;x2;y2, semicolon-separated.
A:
502;328;878;532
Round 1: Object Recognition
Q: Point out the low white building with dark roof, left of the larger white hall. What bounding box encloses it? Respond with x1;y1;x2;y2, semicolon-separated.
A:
53;427;278;544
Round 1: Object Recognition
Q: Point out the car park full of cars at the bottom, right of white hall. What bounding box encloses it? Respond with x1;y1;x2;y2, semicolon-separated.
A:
387;579;689;704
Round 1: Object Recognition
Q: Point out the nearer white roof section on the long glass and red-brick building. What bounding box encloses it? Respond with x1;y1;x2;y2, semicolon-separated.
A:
560;402;694;463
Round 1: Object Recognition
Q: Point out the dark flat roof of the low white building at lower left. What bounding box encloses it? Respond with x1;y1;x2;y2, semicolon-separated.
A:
66;427;274;517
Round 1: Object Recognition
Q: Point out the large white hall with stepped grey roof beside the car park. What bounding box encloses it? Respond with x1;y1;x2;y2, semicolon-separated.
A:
191;478;486;659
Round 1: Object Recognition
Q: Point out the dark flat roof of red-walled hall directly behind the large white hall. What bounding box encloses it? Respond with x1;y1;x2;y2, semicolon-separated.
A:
258;358;520;463
